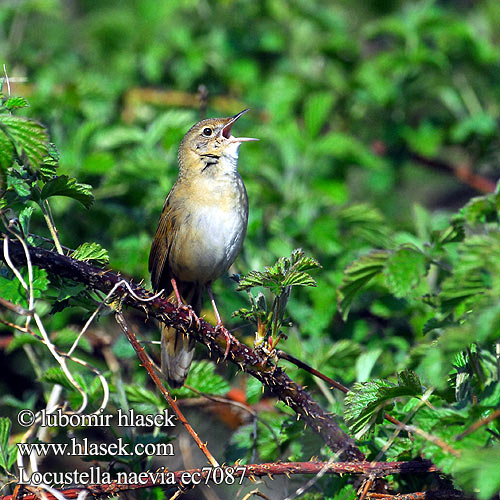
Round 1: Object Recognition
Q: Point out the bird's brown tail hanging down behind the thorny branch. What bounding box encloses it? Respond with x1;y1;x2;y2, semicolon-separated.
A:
160;287;202;388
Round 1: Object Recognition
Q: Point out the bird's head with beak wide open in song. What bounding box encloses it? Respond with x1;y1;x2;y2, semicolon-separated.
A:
179;109;258;170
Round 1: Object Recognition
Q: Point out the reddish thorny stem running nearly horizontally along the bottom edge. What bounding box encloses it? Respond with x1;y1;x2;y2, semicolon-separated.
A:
0;460;440;500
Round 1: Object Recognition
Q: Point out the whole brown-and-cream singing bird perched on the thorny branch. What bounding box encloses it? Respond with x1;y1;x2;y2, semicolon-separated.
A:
149;109;258;388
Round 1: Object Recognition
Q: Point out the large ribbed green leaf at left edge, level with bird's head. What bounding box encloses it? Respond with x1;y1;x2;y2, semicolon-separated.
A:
0;115;49;168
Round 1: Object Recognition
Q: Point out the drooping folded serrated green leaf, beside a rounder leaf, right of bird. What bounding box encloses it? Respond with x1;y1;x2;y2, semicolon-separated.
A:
337;250;391;320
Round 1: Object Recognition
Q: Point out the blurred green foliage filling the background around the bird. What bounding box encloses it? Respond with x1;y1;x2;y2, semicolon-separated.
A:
0;0;500;499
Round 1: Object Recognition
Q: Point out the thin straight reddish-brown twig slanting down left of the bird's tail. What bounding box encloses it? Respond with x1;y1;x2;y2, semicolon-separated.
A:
115;311;219;467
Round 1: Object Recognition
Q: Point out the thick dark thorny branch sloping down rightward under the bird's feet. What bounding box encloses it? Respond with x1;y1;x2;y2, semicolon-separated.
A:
2;238;365;461
